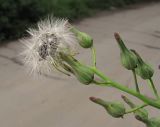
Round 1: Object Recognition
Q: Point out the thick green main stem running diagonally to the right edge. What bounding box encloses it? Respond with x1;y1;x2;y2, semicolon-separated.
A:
91;68;160;109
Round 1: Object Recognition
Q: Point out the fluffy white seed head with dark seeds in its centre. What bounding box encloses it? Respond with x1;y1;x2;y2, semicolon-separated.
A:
22;17;77;74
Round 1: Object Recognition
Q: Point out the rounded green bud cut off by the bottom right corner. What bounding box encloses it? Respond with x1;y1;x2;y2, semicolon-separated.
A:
146;117;160;127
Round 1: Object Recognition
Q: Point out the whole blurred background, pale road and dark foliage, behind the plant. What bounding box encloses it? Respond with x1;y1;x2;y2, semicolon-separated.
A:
0;0;160;127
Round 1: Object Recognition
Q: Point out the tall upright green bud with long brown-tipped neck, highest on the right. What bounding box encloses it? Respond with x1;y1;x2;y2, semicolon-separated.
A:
114;33;138;70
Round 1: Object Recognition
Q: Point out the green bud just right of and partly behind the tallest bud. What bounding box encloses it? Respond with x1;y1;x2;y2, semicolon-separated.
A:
132;50;154;79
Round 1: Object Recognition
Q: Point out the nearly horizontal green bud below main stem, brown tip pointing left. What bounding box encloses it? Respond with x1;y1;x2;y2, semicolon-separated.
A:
90;97;125;118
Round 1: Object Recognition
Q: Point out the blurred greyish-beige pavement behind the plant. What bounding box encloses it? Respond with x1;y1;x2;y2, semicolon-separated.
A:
0;3;160;127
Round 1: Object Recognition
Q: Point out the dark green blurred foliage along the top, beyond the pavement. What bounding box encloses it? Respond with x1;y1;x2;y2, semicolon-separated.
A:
0;0;158;42
